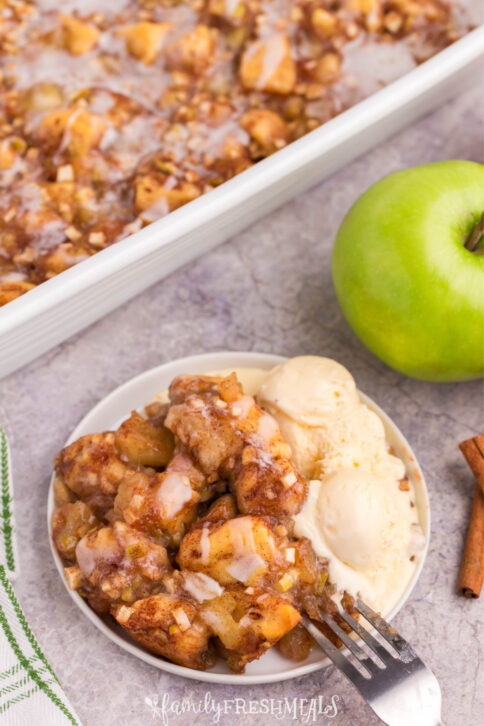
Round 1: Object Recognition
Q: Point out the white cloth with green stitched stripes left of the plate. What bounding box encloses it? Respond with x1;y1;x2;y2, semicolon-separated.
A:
0;428;80;726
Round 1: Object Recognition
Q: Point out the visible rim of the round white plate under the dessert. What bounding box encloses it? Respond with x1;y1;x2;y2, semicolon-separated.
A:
47;352;430;685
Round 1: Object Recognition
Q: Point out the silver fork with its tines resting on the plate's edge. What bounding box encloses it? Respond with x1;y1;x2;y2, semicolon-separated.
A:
302;600;441;726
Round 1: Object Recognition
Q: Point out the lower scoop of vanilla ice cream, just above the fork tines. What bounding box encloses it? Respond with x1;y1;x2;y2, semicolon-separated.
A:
294;469;425;614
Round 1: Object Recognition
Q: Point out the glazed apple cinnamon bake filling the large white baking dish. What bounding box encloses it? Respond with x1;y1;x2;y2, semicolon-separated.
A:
0;0;477;305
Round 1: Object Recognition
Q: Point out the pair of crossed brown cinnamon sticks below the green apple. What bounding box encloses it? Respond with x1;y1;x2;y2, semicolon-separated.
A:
459;434;484;598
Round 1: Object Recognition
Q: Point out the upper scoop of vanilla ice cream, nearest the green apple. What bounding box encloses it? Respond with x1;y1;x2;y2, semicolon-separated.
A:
257;356;405;479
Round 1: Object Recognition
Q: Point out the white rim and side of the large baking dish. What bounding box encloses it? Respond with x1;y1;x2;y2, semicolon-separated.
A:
0;26;484;376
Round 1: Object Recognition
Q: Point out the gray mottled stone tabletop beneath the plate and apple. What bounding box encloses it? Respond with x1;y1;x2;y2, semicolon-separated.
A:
0;86;484;726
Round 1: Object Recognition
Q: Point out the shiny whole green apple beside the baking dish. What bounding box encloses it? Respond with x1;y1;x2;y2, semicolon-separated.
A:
332;161;484;381
